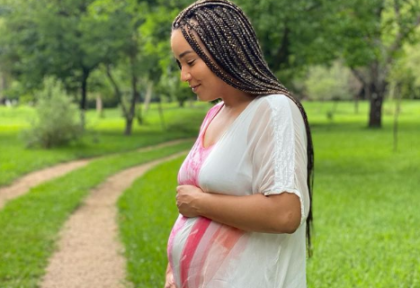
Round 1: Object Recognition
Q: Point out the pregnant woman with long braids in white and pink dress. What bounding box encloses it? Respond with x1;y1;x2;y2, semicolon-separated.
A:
165;0;314;288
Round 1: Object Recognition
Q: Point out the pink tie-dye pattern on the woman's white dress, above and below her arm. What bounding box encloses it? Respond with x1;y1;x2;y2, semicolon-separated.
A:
167;104;246;288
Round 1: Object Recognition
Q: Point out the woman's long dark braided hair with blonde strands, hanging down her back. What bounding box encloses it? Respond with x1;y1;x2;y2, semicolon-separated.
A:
172;0;314;256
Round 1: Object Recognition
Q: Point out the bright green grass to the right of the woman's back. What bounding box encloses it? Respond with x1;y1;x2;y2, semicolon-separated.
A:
308;102;420;288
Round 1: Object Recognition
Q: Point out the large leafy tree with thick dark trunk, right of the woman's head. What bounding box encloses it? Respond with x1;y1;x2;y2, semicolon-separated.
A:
238;0;420;127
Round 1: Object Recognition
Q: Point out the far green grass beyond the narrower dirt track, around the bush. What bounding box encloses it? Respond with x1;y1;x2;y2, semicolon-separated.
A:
0;103;208;186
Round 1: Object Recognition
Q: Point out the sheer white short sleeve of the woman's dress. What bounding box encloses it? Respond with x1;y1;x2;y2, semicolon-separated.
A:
248;95;309;224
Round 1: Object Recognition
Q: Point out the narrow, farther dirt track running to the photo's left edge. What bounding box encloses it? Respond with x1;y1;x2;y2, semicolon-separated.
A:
0;139;188;209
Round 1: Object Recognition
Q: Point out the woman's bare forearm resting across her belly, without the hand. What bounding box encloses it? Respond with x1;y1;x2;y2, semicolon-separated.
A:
196;193;301;233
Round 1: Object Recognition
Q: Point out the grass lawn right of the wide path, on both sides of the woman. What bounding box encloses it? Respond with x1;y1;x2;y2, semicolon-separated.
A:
119;101;420;288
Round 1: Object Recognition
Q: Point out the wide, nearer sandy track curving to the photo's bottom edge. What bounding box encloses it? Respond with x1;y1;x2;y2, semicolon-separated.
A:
41;151;187;288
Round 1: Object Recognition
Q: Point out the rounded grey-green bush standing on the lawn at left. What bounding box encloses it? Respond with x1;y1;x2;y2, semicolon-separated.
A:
23;79;83;149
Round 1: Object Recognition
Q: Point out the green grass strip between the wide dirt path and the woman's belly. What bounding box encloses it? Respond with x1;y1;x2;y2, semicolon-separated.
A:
118;159;182;288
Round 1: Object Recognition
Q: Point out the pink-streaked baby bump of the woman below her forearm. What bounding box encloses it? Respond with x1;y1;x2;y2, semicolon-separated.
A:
168;216;246;288
